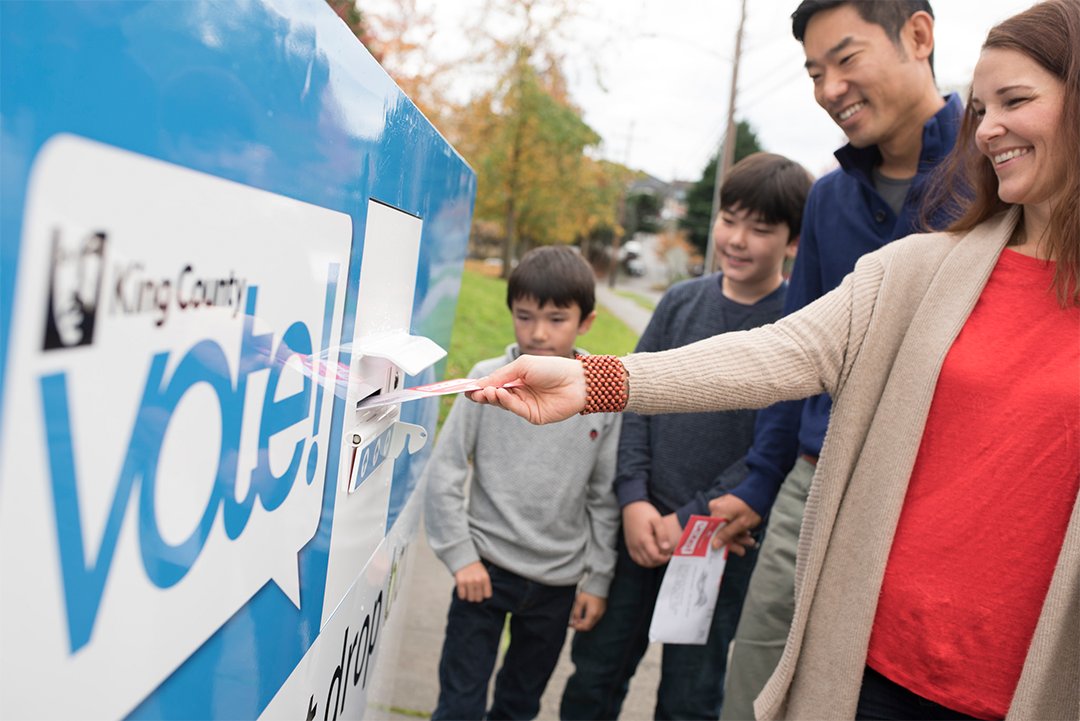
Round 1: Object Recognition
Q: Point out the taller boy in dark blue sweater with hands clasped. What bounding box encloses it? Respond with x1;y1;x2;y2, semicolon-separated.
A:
559;153;812;719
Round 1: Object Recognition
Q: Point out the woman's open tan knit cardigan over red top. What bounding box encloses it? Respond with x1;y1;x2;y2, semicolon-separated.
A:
623;209;1080;719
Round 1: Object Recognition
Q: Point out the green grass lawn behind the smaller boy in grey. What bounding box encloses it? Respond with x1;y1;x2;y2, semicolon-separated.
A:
438;270;637;427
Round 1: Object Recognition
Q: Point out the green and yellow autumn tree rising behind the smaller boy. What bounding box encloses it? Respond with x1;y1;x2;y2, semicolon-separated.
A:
451;0;620;274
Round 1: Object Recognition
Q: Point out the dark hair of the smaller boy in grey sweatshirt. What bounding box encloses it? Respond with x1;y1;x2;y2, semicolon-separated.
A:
507;245;596;321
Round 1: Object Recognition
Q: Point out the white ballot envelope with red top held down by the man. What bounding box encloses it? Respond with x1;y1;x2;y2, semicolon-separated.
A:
649;516;728;645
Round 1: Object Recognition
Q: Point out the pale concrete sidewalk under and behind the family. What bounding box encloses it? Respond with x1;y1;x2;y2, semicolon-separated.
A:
380;276;661;721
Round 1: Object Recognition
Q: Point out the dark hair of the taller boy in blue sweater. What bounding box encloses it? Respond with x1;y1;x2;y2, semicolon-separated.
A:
720;152;813;239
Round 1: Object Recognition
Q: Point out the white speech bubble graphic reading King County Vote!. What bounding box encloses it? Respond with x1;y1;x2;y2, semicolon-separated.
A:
0;136;352;718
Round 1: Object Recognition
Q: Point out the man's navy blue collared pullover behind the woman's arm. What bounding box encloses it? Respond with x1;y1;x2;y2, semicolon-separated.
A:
731;93;963;516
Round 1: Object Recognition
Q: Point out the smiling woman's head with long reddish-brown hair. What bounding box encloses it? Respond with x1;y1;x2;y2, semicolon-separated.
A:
935;0;1080;304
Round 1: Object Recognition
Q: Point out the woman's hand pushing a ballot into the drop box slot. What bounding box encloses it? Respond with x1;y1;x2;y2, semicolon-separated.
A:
467;355;585;425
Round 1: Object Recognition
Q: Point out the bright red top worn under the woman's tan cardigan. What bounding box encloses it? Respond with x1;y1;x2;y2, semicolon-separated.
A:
866;249;1080;719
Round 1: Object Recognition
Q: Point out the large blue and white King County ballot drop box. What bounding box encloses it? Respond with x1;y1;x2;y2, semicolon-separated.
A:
0;0;475;718
